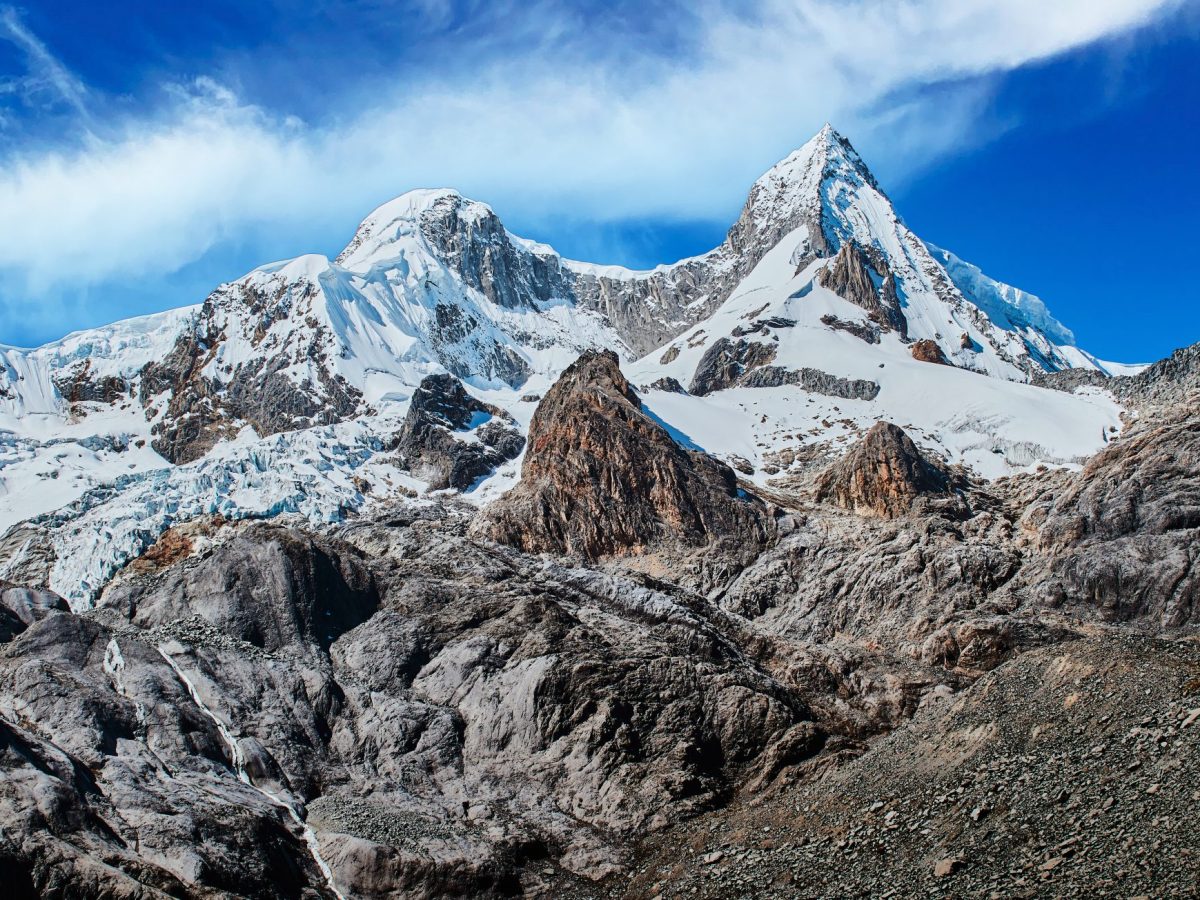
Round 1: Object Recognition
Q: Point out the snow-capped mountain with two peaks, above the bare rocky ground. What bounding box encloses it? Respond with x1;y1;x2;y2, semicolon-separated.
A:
0;126;1142;602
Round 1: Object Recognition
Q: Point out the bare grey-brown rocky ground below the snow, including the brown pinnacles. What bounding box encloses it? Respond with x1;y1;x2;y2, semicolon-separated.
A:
0;348;1200;898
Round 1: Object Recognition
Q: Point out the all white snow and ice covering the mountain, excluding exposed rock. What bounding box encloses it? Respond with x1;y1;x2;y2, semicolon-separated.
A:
0;128;1141;607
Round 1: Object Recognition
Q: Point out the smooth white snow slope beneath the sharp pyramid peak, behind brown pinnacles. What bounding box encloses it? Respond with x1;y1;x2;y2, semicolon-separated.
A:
626;225;1121;484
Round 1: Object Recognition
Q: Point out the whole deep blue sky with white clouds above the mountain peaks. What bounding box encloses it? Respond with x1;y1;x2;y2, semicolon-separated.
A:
0;0;1200;360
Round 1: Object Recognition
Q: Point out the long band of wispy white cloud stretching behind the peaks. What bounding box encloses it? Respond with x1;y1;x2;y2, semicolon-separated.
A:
0;0;1176;300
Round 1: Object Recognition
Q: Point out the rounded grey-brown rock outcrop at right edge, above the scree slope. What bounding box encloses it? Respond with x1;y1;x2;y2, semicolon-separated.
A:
1028;409;1200;628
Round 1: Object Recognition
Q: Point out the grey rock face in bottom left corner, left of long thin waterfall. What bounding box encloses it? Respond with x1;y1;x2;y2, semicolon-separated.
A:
0;613;333;900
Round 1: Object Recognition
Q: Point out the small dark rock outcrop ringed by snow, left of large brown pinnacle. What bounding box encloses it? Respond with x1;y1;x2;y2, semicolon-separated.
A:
396;374;524;491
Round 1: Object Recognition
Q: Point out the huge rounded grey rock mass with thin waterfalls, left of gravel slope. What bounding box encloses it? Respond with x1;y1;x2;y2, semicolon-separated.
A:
0;511;862;898
